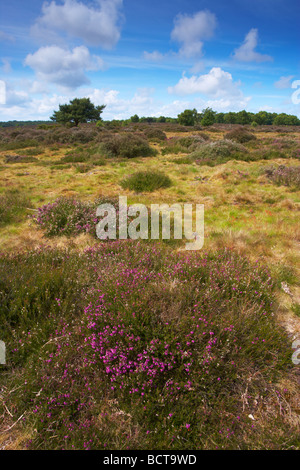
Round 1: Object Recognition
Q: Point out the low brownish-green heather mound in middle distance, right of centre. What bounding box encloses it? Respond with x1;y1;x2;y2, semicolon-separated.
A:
191;140;251;166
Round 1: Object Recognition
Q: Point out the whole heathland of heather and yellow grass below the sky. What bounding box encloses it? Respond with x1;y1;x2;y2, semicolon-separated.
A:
0;109;300;450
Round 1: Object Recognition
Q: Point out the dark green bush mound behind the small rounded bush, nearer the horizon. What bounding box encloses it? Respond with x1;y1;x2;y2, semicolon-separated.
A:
100;134;157;158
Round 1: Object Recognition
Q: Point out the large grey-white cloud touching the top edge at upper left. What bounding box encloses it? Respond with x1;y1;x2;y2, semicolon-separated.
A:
32;0;123;49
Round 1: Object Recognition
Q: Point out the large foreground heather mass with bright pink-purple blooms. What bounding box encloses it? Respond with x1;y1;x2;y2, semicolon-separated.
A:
1;241;297;450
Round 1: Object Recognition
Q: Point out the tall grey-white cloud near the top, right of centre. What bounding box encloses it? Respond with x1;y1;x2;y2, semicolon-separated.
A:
171;10;217;57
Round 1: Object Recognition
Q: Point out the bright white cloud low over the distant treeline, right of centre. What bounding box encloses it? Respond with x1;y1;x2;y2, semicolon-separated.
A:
168;67;249;107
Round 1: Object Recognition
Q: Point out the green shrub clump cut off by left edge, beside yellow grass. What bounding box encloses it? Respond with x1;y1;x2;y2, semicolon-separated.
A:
0;189;32;225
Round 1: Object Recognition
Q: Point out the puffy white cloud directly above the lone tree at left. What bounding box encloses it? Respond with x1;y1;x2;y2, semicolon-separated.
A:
25;46;104;88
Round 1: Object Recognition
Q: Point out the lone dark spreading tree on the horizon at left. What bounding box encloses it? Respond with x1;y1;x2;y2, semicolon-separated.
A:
50;98;105;126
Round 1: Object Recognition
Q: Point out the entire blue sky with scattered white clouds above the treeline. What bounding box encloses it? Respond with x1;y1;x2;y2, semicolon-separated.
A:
0;0;300;121
